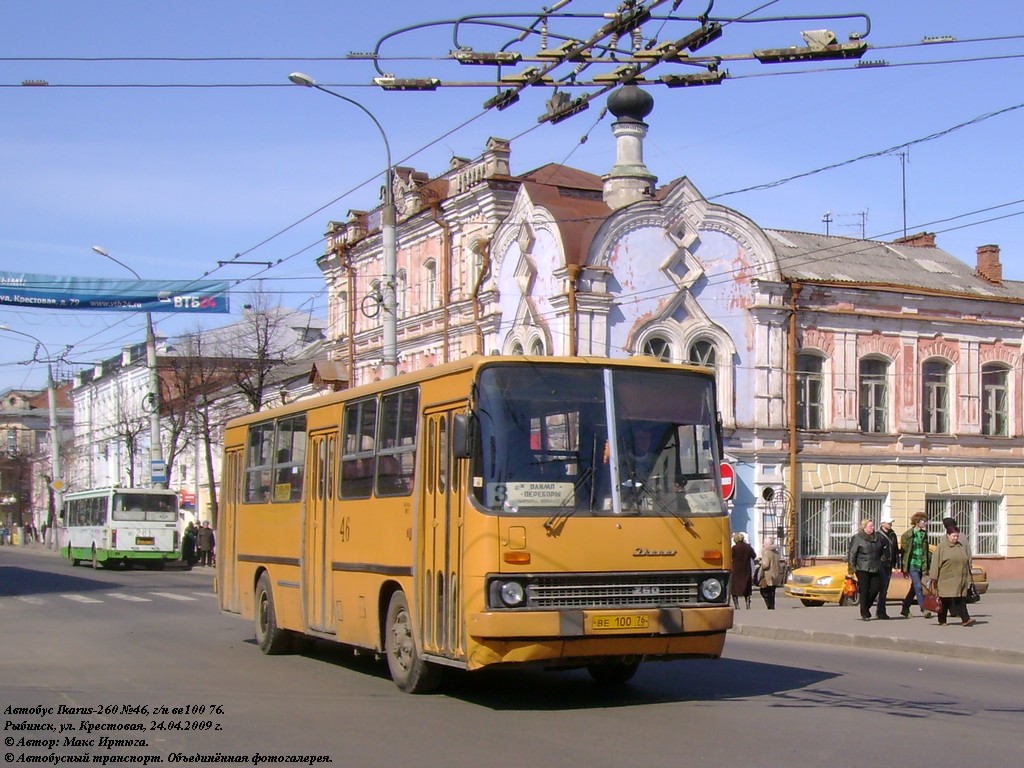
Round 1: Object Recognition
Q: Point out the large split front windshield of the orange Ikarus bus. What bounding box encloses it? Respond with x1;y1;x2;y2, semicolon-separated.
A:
471;366;726;519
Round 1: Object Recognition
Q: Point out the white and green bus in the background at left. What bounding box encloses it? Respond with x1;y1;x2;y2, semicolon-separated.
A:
63;487;180;568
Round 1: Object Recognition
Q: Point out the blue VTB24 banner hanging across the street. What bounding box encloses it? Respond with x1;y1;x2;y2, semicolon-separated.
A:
0;271;228;313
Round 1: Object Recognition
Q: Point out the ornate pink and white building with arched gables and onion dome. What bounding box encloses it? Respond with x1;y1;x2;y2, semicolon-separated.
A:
317;86;1024;579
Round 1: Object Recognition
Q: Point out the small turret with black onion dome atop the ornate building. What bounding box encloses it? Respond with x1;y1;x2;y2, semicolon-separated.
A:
602;84;657;210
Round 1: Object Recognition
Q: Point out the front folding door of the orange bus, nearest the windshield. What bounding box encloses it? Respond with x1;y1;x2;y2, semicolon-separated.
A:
417;409;465;658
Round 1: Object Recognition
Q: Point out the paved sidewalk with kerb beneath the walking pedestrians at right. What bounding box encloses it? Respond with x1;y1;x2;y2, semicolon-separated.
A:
731;583;1024;665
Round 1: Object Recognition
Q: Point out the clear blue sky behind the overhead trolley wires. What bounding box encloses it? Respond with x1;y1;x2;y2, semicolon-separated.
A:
0;0;1024;390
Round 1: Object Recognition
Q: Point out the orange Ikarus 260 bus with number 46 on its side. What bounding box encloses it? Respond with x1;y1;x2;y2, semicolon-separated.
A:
217;356;733;692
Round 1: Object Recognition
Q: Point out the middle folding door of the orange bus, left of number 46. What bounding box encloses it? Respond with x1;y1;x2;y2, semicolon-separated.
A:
302;432;338;633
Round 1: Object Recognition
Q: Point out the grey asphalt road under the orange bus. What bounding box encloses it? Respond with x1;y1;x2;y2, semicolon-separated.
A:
0;548;1024;768
